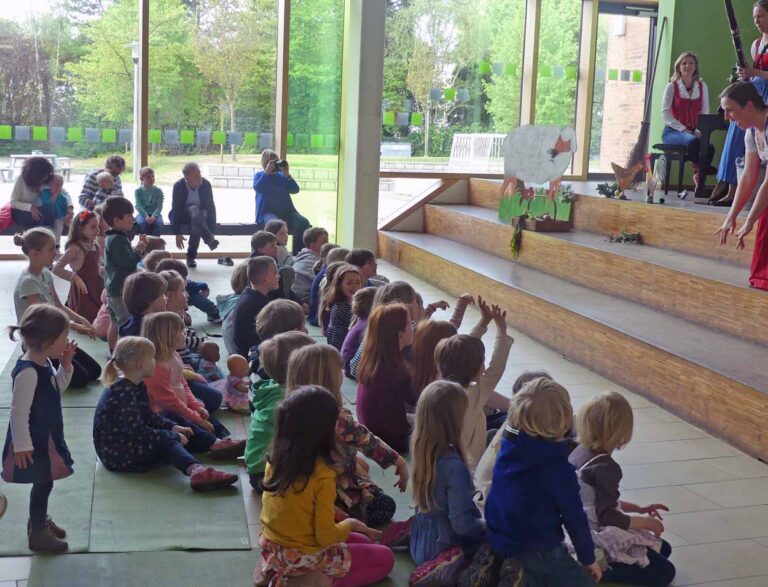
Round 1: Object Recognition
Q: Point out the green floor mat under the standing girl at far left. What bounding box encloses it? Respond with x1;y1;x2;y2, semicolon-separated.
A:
0;408;96;556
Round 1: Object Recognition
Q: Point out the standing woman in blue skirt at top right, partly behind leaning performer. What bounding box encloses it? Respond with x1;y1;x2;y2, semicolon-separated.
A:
709;0;768;206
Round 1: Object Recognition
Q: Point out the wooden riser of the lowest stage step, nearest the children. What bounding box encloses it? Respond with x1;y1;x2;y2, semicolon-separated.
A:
379;233;768;458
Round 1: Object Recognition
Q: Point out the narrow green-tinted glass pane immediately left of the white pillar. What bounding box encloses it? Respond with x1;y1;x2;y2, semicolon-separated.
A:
287;0;344;242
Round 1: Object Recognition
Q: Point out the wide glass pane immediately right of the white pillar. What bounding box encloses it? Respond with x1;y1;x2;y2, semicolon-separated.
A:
381;0;525;173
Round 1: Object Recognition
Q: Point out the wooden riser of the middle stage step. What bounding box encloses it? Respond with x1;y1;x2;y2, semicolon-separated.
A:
425;206;768;344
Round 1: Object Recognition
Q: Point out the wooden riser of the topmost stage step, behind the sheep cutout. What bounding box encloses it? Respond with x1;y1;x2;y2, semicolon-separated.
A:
469;179;753;266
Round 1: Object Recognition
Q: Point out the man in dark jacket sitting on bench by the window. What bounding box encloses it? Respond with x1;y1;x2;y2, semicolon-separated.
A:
169;161;219;267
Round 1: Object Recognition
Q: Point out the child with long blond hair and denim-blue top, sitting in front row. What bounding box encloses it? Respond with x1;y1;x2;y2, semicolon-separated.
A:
410;381;485;585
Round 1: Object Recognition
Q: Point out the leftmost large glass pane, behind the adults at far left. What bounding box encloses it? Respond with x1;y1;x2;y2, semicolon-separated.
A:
0;0;137;202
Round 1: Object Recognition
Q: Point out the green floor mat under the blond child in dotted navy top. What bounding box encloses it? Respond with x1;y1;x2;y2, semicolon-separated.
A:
89;411;251;552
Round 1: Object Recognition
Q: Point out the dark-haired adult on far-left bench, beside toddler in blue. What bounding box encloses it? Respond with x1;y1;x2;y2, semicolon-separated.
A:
11;157;54;229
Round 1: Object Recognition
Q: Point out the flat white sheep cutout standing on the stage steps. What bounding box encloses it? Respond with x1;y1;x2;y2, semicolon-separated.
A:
501;125;577;197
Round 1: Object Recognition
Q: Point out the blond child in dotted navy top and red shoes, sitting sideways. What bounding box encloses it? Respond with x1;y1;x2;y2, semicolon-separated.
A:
93;336;237;491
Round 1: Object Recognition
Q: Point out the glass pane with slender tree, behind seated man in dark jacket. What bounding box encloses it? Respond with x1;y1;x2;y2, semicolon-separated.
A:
146;0;278;237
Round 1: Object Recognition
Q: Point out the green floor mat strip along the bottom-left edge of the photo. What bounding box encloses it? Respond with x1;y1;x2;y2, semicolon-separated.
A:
29;550;255;587
